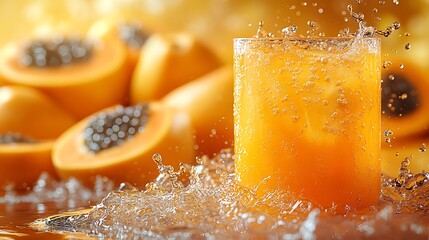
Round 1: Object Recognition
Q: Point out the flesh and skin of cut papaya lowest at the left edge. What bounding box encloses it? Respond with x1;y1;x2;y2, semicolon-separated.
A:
0;141;58;193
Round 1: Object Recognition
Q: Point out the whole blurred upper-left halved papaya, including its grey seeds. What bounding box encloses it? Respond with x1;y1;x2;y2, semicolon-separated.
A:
0;35;129;119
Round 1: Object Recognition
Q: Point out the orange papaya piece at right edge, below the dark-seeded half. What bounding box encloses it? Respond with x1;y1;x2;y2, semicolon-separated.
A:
381;137;429;177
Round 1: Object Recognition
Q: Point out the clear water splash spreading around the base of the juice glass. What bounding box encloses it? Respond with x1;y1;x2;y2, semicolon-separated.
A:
32;150;429;239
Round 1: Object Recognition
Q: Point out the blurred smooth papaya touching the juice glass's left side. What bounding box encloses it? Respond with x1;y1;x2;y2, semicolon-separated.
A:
162;65;234;157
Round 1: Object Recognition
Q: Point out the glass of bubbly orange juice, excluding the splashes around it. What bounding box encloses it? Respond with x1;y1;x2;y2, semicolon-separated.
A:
234;38;381;211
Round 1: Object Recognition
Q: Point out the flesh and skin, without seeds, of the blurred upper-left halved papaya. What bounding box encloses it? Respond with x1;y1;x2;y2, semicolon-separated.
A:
0;34;129;119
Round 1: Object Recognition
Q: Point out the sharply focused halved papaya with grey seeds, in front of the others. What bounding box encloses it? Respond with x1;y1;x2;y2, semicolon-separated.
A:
52;103;194;187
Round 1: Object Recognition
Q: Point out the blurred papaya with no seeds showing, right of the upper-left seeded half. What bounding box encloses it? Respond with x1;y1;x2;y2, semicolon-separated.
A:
130;33;221;104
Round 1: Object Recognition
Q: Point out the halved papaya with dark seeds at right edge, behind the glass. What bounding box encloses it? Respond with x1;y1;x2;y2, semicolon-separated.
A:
382;59;429;138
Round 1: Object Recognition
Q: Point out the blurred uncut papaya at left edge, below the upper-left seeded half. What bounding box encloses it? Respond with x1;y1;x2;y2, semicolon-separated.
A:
0;86;76;140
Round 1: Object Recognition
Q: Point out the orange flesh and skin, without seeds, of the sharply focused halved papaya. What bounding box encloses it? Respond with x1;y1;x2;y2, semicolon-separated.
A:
52;103;194;187
